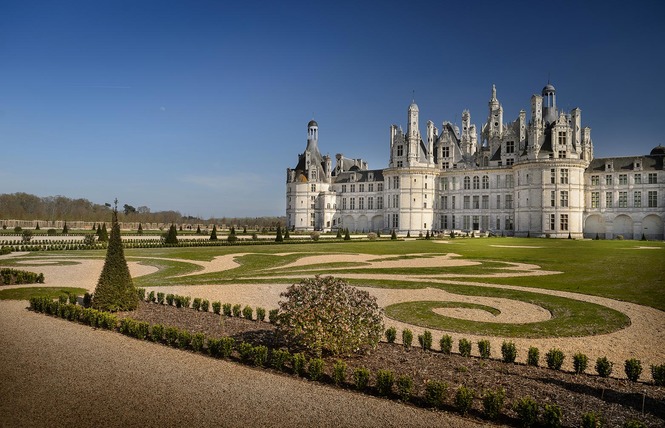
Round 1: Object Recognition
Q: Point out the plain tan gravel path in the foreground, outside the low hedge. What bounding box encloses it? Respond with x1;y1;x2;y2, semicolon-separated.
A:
0;301;482;428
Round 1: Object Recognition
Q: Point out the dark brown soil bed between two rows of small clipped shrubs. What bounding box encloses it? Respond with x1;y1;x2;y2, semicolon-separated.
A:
118;303;665;427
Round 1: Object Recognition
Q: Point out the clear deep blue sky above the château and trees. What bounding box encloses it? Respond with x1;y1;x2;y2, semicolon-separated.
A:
0;0;665;218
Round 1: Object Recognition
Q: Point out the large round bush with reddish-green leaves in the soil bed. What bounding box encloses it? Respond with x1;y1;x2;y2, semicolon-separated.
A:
277;276;383;355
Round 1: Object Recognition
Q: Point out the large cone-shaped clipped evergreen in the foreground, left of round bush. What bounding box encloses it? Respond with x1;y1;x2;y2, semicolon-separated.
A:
92;200;139;311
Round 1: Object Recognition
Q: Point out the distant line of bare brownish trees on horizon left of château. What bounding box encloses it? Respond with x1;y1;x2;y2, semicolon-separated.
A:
0;192;286;228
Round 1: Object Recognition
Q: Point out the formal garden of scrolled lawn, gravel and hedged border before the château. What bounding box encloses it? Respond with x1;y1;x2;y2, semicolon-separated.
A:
0;224;665;426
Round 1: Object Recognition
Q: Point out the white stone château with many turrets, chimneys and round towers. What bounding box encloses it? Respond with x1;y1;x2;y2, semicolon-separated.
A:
286;83;665;239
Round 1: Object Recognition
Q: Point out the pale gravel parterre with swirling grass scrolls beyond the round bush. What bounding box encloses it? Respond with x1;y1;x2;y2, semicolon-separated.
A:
2;249;665;380
